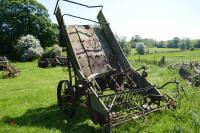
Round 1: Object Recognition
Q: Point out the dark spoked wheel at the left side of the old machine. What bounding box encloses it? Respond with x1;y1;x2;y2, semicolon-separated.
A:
57;80;76;116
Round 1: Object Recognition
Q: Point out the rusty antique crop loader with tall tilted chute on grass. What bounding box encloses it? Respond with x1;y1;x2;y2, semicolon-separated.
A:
54;0;182;132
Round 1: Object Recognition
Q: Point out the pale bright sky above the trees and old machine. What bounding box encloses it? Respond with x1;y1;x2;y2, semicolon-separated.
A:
37;0;200;40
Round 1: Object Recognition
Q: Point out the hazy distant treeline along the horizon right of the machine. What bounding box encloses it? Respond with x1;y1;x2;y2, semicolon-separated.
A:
115;34;200;55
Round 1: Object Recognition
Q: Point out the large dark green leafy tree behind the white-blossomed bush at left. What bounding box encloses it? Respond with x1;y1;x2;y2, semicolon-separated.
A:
0;0;57;53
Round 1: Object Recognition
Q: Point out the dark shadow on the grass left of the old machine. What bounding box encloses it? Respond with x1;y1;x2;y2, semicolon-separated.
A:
2;105;100;133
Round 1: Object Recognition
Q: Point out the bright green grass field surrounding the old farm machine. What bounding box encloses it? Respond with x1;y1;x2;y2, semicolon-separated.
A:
0;50;200;133
